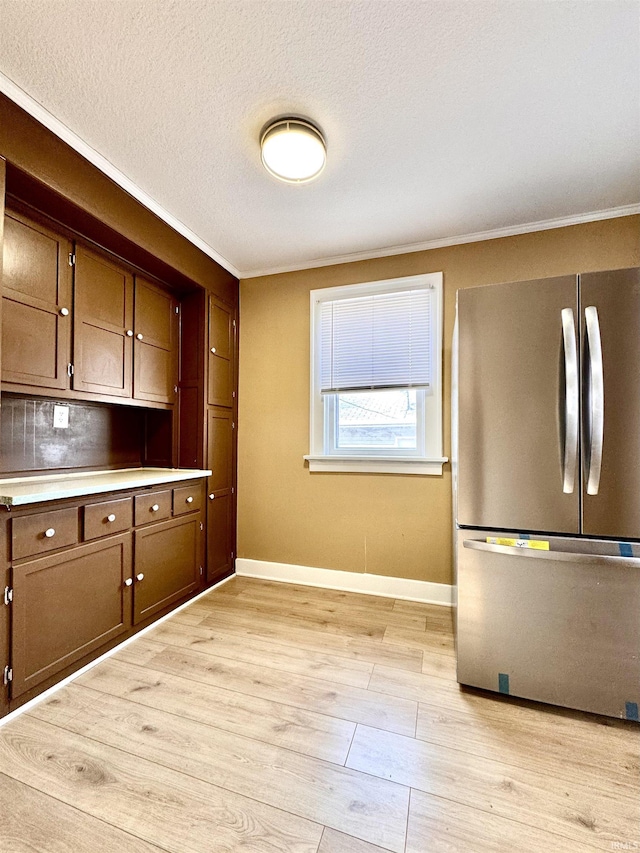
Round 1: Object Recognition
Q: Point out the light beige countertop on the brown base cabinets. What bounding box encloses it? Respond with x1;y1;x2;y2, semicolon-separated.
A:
0;468;211;506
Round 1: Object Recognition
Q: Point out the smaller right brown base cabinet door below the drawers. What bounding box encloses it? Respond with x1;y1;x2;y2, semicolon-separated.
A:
133;513;201;625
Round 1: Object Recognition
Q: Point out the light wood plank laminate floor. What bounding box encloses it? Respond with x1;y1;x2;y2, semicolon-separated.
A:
0;578;640;853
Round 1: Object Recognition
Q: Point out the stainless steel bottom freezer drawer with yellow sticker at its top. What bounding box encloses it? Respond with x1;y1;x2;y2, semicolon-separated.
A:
456;529;640;720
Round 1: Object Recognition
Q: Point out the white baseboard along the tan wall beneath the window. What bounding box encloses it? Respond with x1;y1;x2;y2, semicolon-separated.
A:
236;557;453;607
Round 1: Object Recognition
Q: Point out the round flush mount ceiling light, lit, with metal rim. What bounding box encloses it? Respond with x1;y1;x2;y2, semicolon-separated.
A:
260;118;327;184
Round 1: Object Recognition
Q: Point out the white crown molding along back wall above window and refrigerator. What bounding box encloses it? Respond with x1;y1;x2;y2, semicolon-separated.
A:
240;204;640;279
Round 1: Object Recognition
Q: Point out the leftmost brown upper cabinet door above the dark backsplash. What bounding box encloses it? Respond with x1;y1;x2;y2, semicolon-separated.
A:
2;213;71;389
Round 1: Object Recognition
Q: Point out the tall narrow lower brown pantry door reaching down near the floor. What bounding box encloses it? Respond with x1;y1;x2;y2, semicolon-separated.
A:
207;409;235;583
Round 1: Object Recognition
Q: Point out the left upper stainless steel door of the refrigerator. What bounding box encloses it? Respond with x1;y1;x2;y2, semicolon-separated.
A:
457;276;580;533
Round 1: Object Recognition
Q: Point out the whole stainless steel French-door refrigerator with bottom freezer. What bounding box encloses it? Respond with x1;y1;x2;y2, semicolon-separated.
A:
453;269;640;720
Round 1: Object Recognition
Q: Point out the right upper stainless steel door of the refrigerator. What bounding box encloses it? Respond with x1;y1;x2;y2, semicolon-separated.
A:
580;269;640;539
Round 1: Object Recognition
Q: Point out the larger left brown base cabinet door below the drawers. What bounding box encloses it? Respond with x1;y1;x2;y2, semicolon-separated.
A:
11;533;131;699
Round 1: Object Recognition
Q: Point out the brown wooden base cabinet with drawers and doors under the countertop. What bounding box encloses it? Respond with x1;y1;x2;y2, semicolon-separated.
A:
0;479;205;716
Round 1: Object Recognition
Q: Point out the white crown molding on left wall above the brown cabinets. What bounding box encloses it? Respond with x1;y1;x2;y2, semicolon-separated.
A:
0;72;241;278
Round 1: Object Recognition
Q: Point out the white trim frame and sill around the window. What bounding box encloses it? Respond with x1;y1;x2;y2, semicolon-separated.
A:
304;272;449;475
